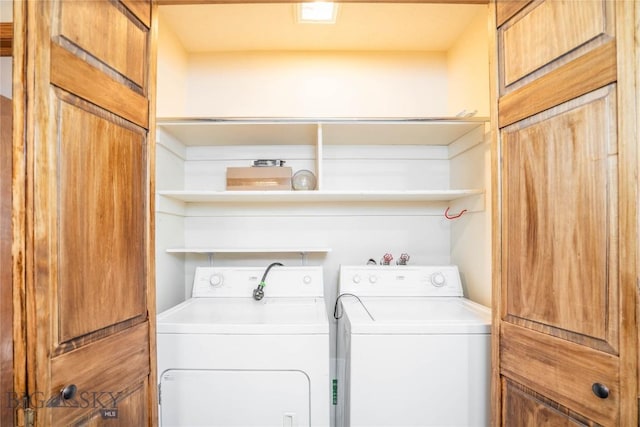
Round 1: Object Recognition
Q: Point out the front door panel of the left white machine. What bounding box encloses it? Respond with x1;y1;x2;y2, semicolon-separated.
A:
160;370;310;427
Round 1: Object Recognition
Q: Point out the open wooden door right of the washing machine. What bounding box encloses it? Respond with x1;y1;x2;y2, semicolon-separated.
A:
494;0;638;426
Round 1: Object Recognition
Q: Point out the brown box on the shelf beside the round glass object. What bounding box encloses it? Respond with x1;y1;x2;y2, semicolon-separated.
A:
227;166;291;191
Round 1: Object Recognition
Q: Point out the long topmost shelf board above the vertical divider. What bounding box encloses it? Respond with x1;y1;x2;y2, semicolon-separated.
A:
157;117;489;146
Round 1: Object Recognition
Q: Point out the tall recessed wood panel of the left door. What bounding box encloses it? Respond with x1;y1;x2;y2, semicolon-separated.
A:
57;98;147;343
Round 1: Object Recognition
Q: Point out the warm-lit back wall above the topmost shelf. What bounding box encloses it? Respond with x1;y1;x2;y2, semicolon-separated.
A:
186;52;447;117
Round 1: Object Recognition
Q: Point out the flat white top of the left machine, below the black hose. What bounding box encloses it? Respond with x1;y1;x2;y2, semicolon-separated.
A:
157;297;329;334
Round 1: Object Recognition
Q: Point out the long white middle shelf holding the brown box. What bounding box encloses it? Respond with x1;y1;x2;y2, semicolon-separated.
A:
158;189;484;203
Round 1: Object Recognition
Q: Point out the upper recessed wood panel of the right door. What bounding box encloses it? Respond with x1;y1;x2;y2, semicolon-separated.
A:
498;0;610;86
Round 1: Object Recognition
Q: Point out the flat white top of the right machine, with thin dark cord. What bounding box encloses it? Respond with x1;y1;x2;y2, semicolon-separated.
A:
341;296;491;334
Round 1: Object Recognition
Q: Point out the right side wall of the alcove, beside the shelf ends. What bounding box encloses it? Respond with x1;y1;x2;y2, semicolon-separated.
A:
447;10;491;306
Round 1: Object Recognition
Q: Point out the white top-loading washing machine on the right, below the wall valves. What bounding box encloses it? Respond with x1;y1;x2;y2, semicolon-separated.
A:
336;266;491;427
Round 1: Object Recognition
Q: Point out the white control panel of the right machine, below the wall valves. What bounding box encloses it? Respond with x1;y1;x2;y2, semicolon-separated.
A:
340;265;463;297
